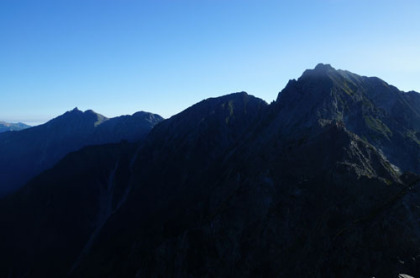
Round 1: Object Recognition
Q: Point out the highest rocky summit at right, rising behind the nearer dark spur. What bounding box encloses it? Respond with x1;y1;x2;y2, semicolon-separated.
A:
277;64;420;172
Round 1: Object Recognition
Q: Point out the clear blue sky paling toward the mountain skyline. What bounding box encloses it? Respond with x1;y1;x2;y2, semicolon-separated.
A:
0;0;420;123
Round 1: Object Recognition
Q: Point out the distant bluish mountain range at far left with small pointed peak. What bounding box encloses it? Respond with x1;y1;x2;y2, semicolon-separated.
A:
0;108;163;196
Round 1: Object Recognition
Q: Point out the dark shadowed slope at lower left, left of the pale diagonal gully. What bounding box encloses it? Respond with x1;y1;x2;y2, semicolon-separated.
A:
0;143;136;277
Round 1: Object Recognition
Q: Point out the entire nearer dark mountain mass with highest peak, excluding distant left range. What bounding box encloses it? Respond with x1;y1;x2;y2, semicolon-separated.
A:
0;64;420;277
